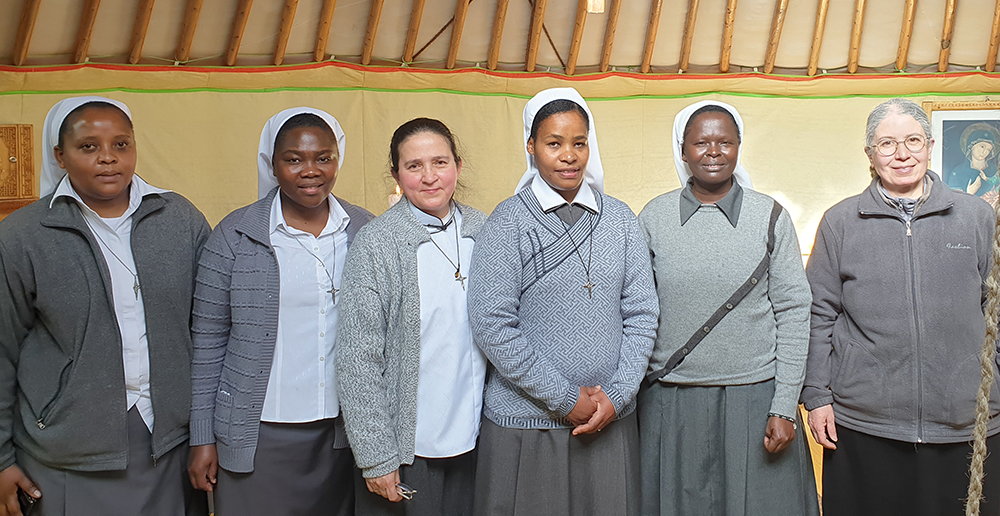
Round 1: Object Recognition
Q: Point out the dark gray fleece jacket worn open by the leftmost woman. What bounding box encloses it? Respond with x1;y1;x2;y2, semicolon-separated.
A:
0;193;209;471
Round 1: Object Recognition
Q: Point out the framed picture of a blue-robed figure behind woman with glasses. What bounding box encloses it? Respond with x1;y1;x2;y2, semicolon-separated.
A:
923;100;1000;207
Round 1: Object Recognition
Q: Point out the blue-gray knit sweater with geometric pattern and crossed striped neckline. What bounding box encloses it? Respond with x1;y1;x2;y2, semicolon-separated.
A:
469;188;659;428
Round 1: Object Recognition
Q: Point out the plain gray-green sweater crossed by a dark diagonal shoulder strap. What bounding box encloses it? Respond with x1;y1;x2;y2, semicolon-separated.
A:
639;189;812;417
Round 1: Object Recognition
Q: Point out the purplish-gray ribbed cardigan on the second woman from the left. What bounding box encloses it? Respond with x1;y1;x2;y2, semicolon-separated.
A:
191;188;373;473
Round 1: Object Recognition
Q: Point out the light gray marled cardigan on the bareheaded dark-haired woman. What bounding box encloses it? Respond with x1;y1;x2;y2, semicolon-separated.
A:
337;198;486;478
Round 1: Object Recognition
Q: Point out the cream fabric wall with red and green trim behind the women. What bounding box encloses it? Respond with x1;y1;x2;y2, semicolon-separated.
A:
0;64;996;253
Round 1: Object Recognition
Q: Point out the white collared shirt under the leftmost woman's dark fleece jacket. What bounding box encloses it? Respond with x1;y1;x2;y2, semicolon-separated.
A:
49;176;169;432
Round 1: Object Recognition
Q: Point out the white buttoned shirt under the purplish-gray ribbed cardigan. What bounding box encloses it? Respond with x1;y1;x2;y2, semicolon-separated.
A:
260;192;351;423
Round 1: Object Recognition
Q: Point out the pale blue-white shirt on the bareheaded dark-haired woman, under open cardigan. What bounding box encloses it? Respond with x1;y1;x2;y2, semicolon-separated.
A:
411;206;486;458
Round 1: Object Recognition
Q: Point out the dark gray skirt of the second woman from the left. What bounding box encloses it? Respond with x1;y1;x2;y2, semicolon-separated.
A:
215;419;360;516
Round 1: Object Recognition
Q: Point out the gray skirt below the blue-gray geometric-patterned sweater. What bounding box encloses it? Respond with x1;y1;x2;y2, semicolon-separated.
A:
475;413;639;516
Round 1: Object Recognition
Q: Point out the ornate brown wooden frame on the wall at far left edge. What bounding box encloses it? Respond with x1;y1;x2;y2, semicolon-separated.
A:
0;124;36;219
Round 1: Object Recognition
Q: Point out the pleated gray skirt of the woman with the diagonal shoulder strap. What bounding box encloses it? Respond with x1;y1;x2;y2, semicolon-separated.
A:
638;380;819;516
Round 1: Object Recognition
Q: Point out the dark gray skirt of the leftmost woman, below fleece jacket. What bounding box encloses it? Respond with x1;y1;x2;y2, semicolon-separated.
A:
17;408;207;516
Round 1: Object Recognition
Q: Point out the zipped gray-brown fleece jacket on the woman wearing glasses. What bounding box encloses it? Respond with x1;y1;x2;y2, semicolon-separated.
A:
802;172;1000;443
